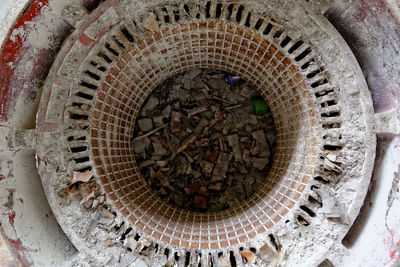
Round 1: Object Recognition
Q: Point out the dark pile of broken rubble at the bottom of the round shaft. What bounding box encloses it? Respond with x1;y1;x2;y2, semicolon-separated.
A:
132;69;276;214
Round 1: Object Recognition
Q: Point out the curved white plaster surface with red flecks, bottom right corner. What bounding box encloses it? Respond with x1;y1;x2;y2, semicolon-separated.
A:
344;137;400;267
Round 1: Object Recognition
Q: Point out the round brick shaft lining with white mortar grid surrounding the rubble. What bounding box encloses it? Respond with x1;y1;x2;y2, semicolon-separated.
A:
90;21;319;250
